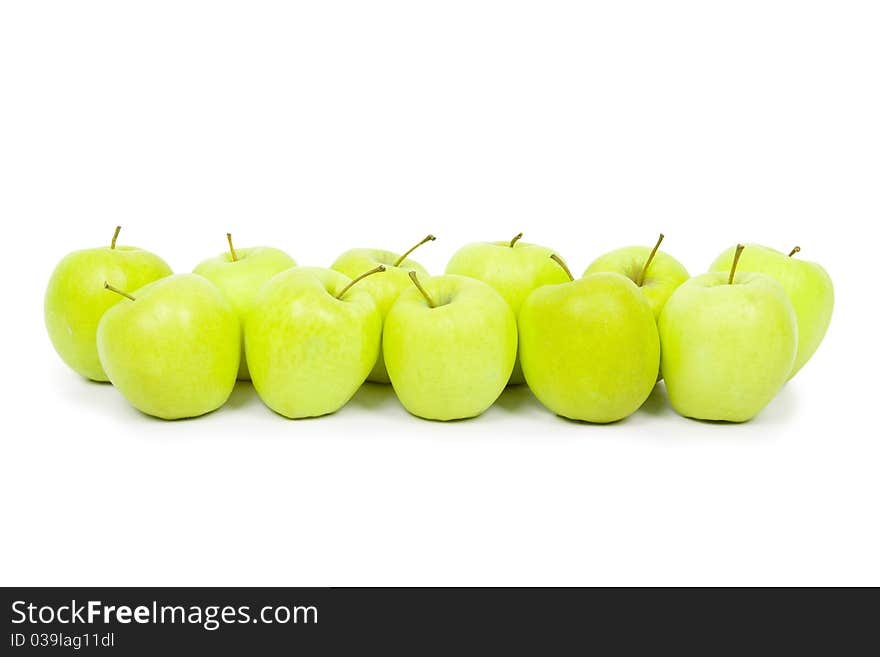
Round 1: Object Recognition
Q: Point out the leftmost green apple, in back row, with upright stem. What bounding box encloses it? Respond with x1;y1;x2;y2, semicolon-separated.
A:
43;226;171;381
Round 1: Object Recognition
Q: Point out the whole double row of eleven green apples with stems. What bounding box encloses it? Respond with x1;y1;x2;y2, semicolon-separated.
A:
45;227;834;422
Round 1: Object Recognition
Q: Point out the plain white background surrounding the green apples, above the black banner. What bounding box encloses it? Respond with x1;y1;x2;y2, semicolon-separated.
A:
0;0;880;585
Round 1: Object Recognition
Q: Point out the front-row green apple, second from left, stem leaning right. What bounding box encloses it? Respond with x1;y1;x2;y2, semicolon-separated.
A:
244;267;382;418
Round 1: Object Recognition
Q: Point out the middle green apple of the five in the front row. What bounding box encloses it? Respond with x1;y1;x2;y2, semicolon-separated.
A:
383;275;517;420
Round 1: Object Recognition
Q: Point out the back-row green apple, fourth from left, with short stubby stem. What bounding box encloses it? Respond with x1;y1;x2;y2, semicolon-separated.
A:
446;233;568;385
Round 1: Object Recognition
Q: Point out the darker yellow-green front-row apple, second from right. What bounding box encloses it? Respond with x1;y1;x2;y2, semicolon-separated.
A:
519;273;660;423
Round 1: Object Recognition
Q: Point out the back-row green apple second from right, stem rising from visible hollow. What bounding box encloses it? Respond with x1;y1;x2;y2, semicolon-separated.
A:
584;233;690;319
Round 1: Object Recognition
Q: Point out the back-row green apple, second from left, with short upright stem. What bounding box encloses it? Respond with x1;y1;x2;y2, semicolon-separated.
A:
193;233;296;381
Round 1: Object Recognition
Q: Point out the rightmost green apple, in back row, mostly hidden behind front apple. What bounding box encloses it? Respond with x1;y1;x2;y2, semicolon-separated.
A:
709;244;834;379
